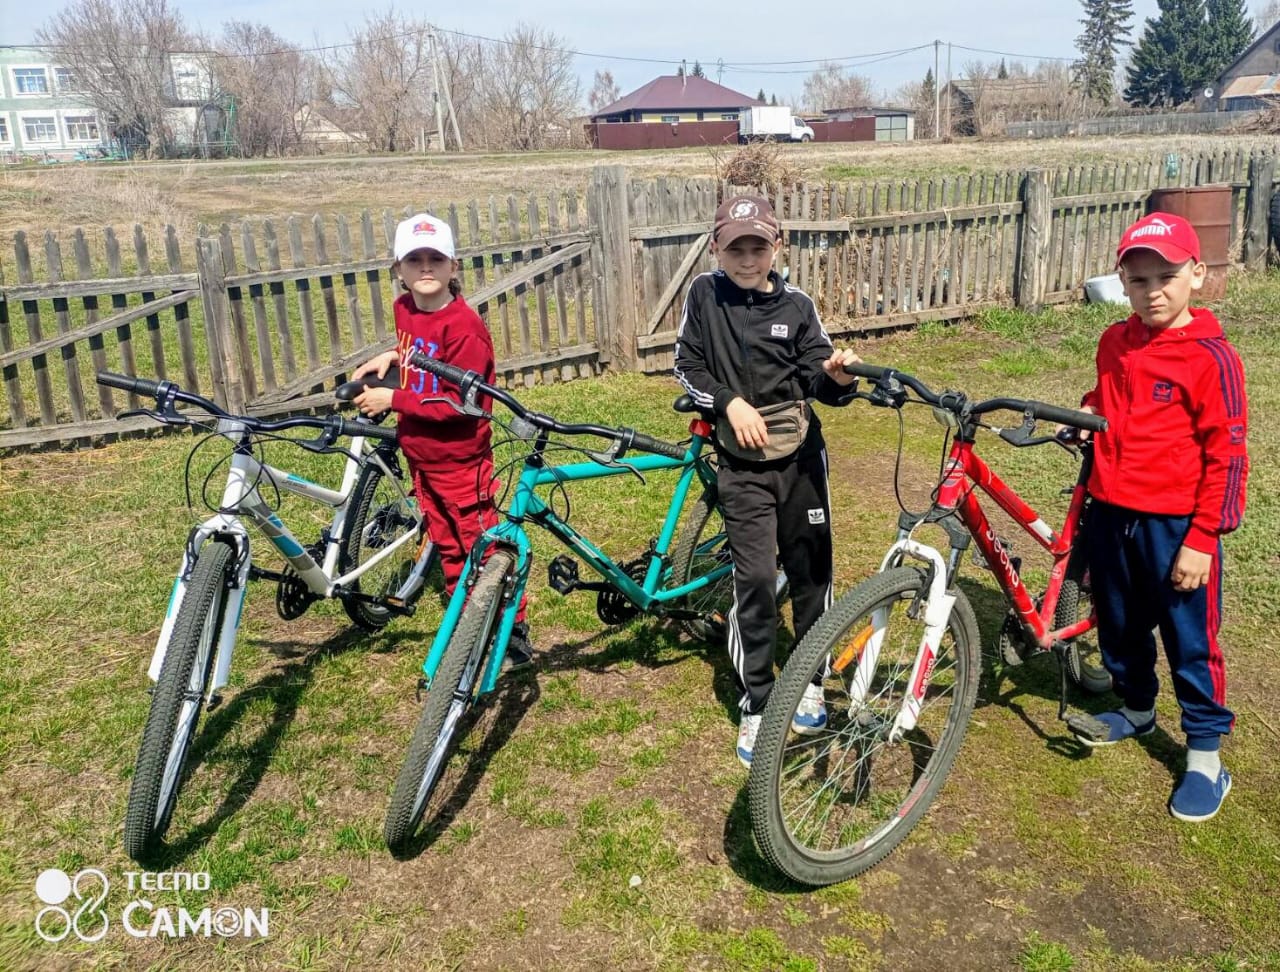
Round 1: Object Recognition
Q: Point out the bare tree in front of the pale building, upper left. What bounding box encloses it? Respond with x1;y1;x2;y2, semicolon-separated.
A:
36;0;204;156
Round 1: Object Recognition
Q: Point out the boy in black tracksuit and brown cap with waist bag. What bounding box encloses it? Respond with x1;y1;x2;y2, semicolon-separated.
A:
676;196;859;766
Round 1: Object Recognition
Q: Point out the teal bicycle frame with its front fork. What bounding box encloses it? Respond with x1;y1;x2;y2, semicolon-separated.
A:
422;419;733;694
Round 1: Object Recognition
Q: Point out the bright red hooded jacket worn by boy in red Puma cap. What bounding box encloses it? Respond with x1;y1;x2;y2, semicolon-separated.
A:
1083;309;1249;553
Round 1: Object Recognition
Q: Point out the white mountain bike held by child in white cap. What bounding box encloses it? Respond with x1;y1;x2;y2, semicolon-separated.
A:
97;371;435;862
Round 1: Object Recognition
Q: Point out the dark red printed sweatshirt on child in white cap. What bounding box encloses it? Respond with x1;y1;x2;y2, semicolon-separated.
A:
392;293;495;466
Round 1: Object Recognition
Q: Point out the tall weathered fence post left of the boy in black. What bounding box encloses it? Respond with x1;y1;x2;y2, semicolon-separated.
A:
589;165;639;371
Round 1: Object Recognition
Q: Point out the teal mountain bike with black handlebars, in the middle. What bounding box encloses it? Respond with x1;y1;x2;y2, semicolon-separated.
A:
384;353;786;854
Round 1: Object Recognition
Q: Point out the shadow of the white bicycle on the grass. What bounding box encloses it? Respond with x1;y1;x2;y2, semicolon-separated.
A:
140;628;416;868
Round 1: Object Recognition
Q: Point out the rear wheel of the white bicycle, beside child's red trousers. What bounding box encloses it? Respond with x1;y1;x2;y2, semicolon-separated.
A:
338;461;421;631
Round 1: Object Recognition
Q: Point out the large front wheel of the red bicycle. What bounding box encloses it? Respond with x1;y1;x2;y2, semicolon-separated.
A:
748;566;980;886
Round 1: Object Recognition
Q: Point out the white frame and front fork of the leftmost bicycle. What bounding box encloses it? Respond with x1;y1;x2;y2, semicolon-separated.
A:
147;419;416;695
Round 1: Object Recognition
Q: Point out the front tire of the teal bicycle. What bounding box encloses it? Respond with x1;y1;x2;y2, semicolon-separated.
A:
383;551;516;854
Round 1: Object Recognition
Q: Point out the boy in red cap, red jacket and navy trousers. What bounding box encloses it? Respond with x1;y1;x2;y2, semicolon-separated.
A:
1080;213;1249;821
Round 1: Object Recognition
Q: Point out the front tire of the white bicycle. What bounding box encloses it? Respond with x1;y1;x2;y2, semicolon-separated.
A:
124;540;234;863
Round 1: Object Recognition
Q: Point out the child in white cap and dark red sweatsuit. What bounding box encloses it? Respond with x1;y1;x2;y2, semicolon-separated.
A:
352;213;530;665
